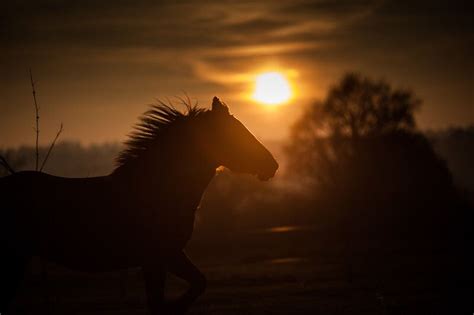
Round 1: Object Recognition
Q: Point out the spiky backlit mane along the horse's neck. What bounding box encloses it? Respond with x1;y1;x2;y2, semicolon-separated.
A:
116;99;208;167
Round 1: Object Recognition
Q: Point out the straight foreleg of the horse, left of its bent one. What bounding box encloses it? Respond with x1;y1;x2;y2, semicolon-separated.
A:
143;263;166;315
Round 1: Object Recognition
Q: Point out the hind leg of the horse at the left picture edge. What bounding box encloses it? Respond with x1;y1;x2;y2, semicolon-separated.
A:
0;251;28;315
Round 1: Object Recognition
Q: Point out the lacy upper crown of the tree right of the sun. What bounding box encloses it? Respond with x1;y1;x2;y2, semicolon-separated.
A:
293;73;421;138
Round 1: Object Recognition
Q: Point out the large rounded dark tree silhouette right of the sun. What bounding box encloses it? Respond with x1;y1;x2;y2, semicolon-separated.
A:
287;73;451;207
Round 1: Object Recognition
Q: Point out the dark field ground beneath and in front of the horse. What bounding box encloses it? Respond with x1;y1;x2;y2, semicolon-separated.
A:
8;227;473;315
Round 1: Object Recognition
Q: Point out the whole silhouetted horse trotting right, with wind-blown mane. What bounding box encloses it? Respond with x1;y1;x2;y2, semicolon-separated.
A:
0;97;278;315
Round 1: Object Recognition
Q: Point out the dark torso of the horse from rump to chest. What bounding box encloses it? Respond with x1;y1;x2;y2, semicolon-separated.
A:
0;159;213;271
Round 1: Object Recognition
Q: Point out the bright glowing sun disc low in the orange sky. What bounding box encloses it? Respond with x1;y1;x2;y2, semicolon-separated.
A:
252;72;292;106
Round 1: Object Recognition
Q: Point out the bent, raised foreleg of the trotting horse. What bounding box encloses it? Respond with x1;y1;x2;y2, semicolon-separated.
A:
166;251;207;314
